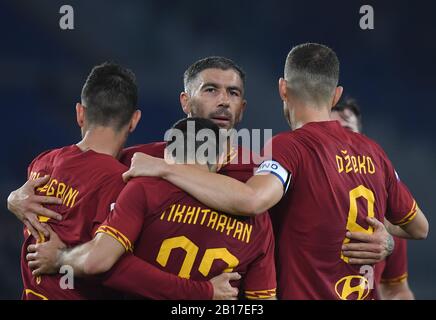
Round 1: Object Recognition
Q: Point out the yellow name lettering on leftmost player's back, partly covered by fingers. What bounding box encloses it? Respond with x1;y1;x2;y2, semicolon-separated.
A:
29;171;79;208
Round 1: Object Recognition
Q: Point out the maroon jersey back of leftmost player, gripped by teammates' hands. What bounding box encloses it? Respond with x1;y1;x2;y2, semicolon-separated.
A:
21;145;127;300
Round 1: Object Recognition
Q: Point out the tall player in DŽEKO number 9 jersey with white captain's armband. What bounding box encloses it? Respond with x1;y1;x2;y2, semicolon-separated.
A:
124;43;428;299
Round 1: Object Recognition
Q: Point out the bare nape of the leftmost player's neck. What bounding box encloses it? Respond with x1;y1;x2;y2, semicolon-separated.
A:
76;127;126;158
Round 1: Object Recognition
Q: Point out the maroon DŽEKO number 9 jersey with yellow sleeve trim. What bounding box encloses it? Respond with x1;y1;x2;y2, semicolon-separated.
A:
260;121;416;299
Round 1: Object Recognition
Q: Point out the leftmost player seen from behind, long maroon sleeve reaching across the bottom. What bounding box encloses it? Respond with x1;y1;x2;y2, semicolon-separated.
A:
16;63;235;299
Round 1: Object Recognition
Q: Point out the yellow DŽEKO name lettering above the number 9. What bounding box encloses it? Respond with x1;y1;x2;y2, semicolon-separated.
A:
336;150;375;174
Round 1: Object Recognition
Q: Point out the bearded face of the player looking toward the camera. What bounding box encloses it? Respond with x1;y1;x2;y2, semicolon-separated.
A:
184;69;246;129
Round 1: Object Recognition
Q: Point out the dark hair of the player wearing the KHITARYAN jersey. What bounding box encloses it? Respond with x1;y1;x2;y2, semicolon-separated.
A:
165;117;223;164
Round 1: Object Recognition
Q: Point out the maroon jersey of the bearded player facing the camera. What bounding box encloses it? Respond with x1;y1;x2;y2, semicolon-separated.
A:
120;142;257;182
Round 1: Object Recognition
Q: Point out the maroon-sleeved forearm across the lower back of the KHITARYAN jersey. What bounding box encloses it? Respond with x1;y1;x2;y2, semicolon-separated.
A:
103;254;213;300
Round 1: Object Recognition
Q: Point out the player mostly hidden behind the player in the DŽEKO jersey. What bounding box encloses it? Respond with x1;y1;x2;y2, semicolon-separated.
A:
331;98;414;300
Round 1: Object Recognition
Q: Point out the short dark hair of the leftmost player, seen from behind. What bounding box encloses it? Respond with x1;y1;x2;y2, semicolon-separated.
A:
81;62;138;130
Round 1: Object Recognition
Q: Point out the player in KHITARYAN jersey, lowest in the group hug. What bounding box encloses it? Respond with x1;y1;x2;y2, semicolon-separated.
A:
25;117;276;299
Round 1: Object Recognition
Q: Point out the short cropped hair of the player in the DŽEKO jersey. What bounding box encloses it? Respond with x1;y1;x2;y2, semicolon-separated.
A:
284;43;339;104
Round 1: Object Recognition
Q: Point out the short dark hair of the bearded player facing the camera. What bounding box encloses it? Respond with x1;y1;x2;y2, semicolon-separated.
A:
183;56;245;91
